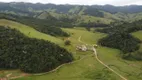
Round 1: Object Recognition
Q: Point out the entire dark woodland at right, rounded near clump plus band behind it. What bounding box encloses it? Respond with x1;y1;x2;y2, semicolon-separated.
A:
97;20;142;60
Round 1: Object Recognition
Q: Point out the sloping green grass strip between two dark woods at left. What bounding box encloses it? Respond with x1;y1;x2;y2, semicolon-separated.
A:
0;19;63;45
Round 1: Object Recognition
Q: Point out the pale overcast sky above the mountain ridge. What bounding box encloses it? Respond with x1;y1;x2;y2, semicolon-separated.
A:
0;0;142;6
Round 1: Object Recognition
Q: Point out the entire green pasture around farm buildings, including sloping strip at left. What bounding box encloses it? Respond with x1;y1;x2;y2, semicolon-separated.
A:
0;20;142;80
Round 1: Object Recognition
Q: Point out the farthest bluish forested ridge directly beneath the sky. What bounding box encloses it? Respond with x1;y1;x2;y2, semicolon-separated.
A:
0;2;142;13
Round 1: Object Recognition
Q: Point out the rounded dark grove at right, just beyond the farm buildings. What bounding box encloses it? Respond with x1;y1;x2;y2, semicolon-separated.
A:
99;33;141;53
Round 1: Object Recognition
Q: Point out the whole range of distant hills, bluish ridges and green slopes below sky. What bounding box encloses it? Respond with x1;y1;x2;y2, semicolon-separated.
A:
0;2;142;25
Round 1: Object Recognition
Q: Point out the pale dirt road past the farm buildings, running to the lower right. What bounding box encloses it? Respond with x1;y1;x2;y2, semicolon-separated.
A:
78;36;127;80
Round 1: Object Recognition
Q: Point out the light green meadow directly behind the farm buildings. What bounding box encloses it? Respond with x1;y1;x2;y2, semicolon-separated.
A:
63;28;106;44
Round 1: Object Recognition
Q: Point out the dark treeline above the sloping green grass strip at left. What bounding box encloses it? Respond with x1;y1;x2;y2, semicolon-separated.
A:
0;14;71;37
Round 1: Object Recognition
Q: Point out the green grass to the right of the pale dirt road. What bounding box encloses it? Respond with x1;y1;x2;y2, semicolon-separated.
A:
97;47;142;80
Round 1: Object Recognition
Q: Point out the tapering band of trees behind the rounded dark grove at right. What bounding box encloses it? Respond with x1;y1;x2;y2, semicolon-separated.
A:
96;20;142;33
